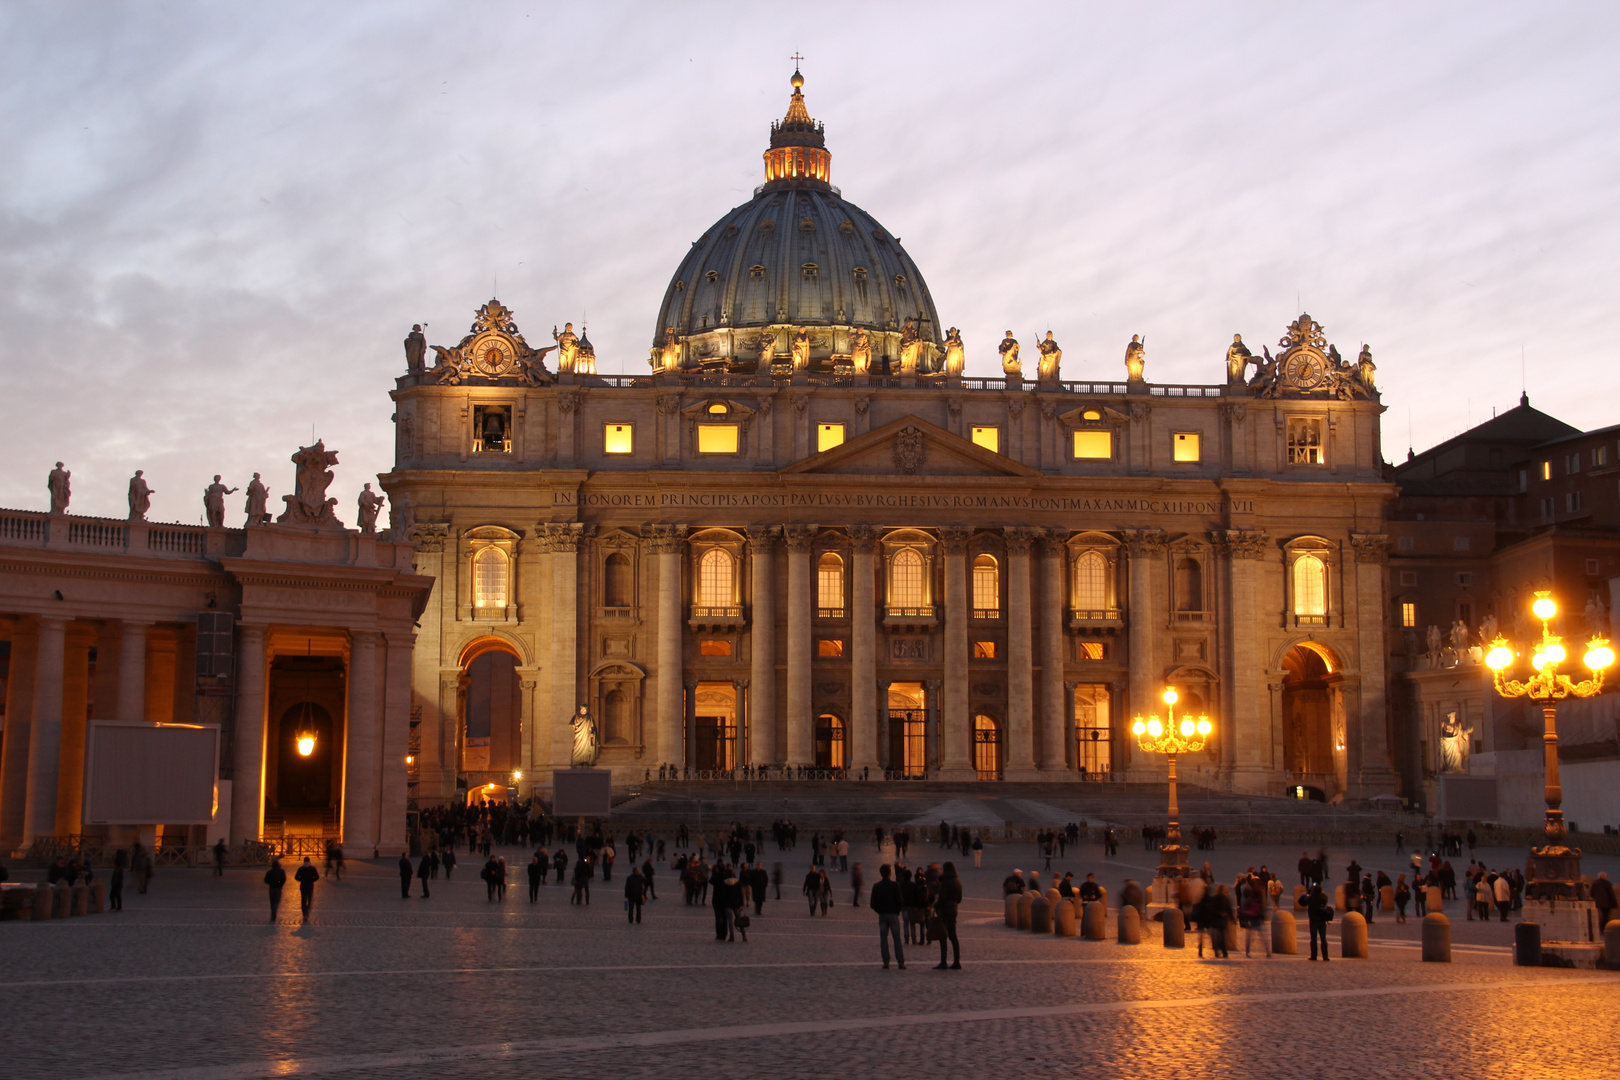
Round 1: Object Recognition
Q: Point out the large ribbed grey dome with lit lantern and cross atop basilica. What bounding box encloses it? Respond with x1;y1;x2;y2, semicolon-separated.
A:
653;71;941;369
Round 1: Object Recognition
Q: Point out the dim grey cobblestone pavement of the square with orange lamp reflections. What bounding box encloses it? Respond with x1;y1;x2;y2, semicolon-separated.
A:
0;844;1620;1080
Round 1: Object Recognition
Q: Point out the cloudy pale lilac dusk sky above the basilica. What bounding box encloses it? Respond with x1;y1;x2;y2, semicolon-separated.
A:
0;0;1620;525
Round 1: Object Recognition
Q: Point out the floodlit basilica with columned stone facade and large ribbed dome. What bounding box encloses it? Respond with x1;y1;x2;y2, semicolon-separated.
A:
382;73;1396;801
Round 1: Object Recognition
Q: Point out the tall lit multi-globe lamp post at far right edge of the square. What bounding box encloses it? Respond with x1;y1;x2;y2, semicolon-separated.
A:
1486;589;1615;900
